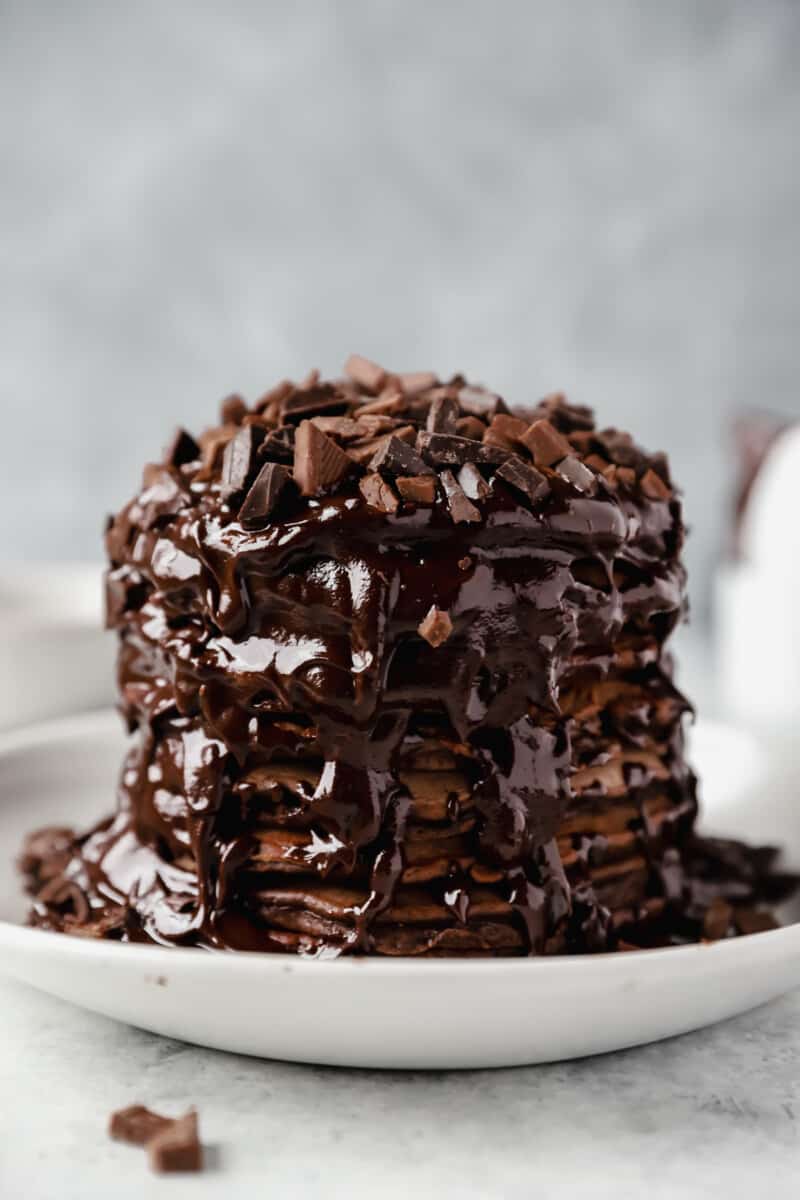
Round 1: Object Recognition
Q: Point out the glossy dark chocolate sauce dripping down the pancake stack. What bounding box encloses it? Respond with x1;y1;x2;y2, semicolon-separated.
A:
23;364;786;954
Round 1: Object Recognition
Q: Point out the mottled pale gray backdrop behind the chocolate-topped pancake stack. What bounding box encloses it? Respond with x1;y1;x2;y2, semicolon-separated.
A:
0;0;800;613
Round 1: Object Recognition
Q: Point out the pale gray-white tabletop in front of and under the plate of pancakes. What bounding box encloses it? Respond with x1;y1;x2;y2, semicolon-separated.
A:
0;983;800;1200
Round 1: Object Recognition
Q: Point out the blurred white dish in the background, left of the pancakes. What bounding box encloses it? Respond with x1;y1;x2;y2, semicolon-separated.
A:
0;563;116;728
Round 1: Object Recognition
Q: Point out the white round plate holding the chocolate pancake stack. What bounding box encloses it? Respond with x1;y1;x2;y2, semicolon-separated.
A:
0;714;800;1068
